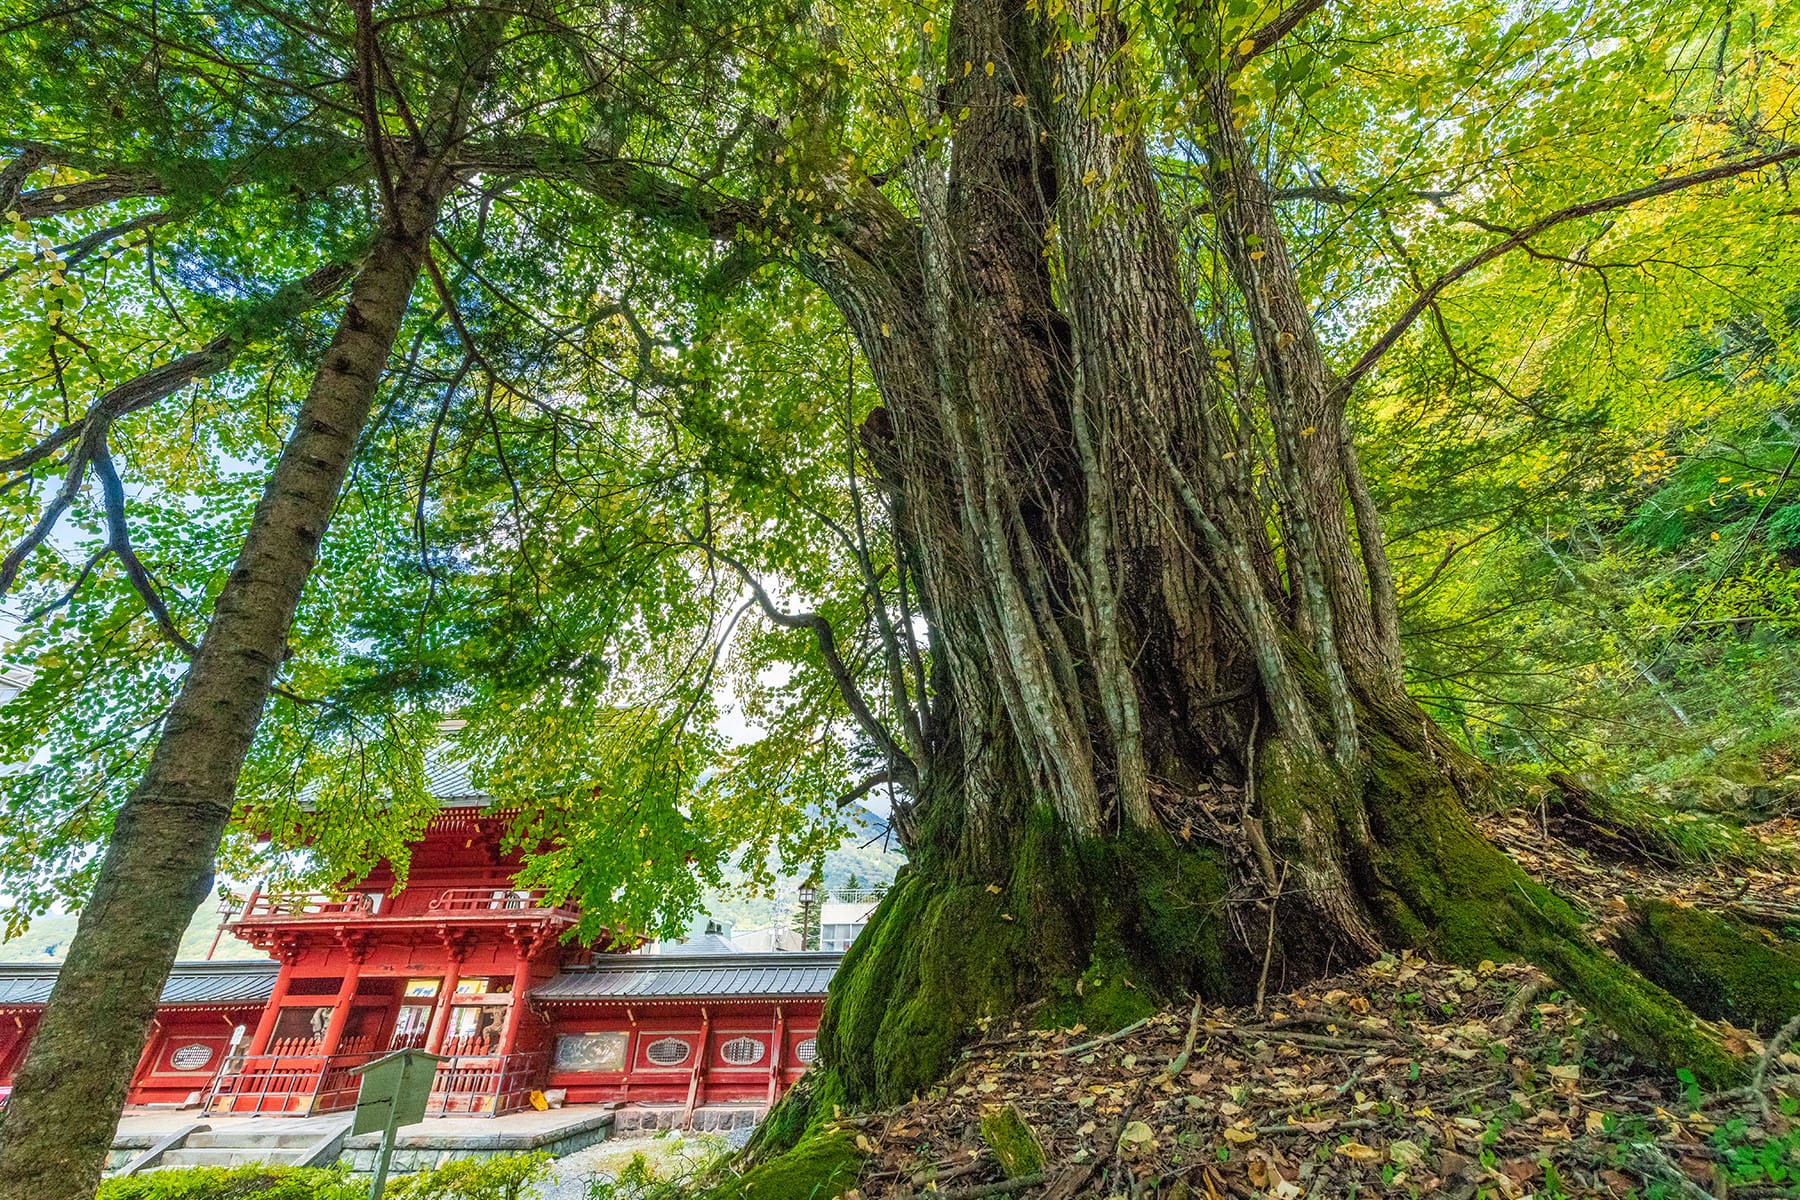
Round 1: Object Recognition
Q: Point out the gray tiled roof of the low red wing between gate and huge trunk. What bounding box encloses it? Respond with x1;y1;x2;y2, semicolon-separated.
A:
531;952;842;1004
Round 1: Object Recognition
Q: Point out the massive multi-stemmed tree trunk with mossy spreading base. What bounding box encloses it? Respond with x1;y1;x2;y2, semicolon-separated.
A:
772;0;1733;1137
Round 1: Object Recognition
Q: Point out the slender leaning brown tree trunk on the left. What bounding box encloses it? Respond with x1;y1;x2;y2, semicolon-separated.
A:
0;164;452;1200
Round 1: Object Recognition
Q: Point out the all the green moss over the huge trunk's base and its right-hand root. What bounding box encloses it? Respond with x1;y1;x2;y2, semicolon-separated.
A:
810;734;1741;1129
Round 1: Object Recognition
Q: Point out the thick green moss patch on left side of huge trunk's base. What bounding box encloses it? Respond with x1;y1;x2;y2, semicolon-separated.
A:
819;815;1233;1106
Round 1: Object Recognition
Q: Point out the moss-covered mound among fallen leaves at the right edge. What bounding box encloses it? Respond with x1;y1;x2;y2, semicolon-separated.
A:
1616;900;1800;1034
